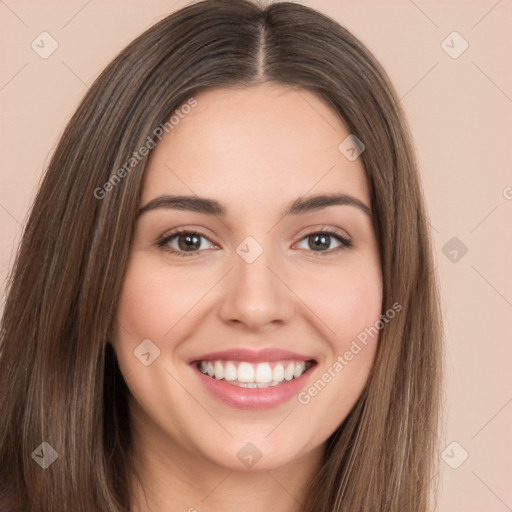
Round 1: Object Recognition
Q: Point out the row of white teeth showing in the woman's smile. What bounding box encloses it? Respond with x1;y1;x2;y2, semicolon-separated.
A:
198;361;308;388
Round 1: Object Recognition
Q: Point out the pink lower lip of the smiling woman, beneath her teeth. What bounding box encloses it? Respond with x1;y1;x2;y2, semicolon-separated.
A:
192;365;316;409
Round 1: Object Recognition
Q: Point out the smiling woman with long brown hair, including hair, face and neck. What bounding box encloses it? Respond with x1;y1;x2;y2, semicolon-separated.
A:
0;0;441;512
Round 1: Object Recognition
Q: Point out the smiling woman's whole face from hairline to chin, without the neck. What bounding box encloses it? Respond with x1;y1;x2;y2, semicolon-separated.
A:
111;84;382;471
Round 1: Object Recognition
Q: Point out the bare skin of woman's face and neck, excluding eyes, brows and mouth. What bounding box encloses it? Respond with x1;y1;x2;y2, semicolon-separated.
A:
112;84;382;512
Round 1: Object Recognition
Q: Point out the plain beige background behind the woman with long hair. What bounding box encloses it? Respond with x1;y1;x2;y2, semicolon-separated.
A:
0;0;512;512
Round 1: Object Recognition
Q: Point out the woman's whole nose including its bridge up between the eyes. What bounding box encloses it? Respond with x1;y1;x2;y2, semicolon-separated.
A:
221;236;292;328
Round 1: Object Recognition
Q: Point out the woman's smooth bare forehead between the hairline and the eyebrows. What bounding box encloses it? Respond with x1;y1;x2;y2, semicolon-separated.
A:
142;84;369;209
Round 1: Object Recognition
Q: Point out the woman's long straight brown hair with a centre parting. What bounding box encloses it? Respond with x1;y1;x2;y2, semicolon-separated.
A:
0;0;442;512
